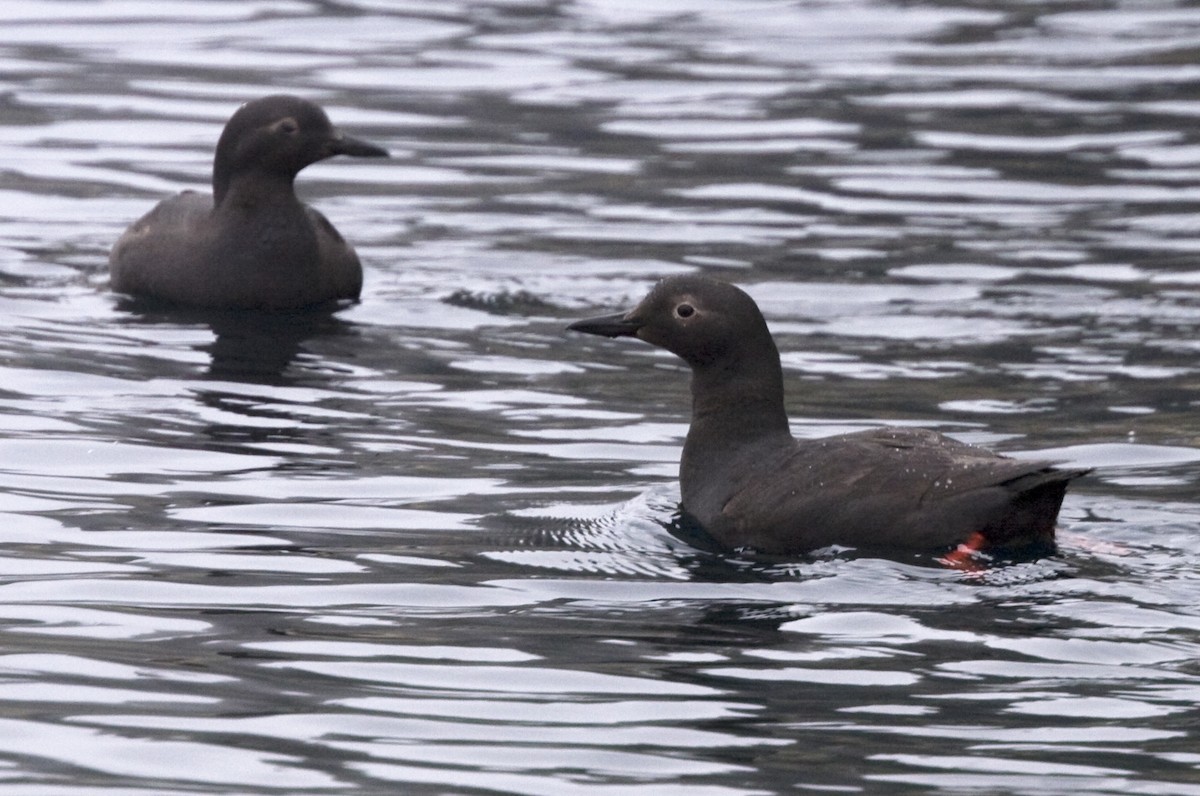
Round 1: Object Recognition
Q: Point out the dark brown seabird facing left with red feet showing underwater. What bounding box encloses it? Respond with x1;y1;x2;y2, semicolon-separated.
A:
569;276;1088;553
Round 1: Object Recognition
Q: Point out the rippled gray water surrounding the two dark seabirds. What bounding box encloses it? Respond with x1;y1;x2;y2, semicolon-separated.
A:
0;0;1200;796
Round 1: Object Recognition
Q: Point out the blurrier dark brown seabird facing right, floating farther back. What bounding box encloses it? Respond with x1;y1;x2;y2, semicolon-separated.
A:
108;95;388;310
